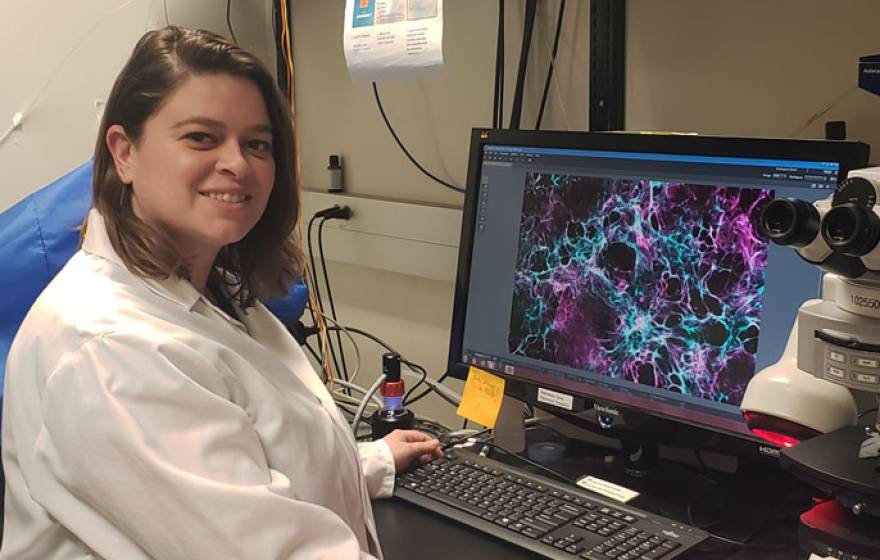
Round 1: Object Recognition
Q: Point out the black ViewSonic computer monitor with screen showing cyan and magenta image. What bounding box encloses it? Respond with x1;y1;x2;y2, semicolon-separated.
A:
449;129;869;458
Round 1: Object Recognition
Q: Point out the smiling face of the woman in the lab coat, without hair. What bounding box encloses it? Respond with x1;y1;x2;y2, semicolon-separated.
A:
108;74;275;261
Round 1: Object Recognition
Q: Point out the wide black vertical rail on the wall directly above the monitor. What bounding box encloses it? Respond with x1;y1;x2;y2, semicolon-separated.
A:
589;0;626;131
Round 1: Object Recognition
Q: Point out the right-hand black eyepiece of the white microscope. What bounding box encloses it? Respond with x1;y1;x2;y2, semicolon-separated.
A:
822;202;880;257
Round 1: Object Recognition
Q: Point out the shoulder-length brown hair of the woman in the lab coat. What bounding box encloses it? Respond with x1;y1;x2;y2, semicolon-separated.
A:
92;26;304;307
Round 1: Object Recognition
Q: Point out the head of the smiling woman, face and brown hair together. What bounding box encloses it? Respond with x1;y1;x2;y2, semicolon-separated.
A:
93;28;303;307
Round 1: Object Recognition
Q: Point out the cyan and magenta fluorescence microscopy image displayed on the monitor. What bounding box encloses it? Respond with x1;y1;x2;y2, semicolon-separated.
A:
508;173;773;405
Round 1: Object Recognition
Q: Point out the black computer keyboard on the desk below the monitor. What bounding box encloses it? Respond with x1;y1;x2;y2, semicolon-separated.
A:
394;451;708;560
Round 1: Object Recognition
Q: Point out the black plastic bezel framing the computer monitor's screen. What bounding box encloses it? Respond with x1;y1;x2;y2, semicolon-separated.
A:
447;128;870;450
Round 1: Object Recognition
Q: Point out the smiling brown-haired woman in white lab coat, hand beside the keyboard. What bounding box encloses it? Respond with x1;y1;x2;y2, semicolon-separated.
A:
0;27;441;560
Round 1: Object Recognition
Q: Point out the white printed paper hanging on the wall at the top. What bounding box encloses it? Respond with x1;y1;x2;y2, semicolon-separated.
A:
345;0;443;81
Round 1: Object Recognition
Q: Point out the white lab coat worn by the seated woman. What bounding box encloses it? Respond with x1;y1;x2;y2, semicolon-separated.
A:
0;210;394;560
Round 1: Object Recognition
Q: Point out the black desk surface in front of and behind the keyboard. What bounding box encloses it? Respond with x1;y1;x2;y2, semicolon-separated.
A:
373;424;809;560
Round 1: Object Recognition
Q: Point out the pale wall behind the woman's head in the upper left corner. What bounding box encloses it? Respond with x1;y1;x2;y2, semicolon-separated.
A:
0;0;275;210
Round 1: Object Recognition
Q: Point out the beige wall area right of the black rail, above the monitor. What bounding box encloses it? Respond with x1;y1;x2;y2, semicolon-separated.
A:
626;0;880;149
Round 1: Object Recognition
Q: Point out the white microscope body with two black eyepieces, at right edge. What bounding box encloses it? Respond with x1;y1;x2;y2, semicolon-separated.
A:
740;168;880;440
